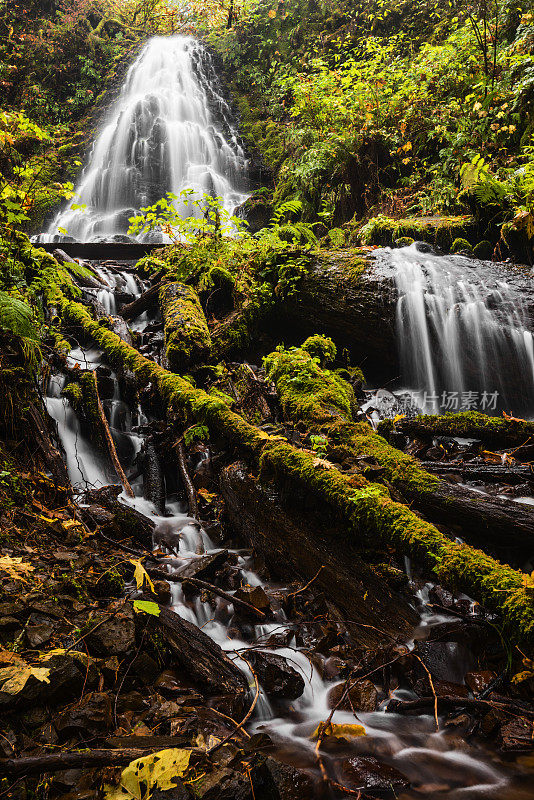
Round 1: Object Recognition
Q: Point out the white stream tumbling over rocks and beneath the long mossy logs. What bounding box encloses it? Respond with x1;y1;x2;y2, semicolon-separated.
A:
47;271;534;800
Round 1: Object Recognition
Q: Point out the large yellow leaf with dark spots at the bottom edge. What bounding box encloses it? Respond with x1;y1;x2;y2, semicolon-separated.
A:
104;747;191;800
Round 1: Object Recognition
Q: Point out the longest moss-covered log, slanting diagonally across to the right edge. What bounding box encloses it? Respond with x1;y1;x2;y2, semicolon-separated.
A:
54;297;534;641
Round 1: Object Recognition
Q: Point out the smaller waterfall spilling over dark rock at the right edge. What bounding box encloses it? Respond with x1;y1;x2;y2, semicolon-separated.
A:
391;245;534;414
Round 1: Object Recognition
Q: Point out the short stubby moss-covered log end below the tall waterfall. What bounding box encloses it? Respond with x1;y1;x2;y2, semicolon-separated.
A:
159;283;211;372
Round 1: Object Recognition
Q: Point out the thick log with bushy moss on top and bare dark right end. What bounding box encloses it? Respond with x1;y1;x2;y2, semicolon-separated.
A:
265;348;534;557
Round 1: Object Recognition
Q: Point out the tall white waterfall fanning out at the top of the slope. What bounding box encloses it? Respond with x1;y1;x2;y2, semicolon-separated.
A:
39;36;248;242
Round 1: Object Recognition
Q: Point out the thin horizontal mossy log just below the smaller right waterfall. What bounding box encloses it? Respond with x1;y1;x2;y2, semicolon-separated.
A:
384;411;534;449
